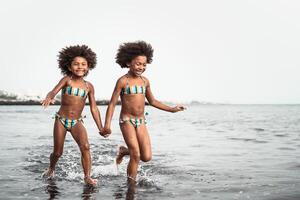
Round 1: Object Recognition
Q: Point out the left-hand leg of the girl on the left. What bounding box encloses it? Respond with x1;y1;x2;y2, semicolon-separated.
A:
43;119;67;178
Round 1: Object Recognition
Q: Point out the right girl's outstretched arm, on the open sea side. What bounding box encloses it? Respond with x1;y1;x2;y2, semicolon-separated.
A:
146;79;185;113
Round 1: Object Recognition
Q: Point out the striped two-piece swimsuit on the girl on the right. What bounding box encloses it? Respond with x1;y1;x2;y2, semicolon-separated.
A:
119;75;147;128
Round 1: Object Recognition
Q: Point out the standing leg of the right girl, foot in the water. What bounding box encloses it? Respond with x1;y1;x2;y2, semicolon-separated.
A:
120;123;140;180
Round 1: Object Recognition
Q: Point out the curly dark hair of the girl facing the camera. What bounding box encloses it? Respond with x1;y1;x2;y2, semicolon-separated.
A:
57;45;97;76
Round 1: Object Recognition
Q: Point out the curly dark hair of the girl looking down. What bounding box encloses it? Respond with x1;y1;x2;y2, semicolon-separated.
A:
116;41;153;68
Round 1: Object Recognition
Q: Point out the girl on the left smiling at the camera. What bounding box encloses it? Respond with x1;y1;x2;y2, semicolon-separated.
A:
42;45;103;186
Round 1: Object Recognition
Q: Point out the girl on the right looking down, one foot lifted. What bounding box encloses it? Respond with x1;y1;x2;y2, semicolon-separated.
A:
102;41;184;183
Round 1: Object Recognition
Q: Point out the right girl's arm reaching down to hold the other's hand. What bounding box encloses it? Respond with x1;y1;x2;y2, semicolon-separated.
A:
104;78;124;131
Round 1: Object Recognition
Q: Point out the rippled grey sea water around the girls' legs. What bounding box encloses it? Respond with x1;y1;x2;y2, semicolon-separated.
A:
0;105;300;200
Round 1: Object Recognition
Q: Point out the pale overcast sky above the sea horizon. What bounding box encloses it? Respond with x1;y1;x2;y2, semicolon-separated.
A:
0;0;300;104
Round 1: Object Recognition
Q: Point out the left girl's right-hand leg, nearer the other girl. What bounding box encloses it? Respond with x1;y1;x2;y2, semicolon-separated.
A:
71;122;97;186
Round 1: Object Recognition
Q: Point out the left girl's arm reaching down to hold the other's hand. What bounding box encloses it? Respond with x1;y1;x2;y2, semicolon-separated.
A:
88;83;103;135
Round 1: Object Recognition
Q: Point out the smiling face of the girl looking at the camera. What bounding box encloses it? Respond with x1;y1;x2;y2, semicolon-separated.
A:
69;56;89;77
